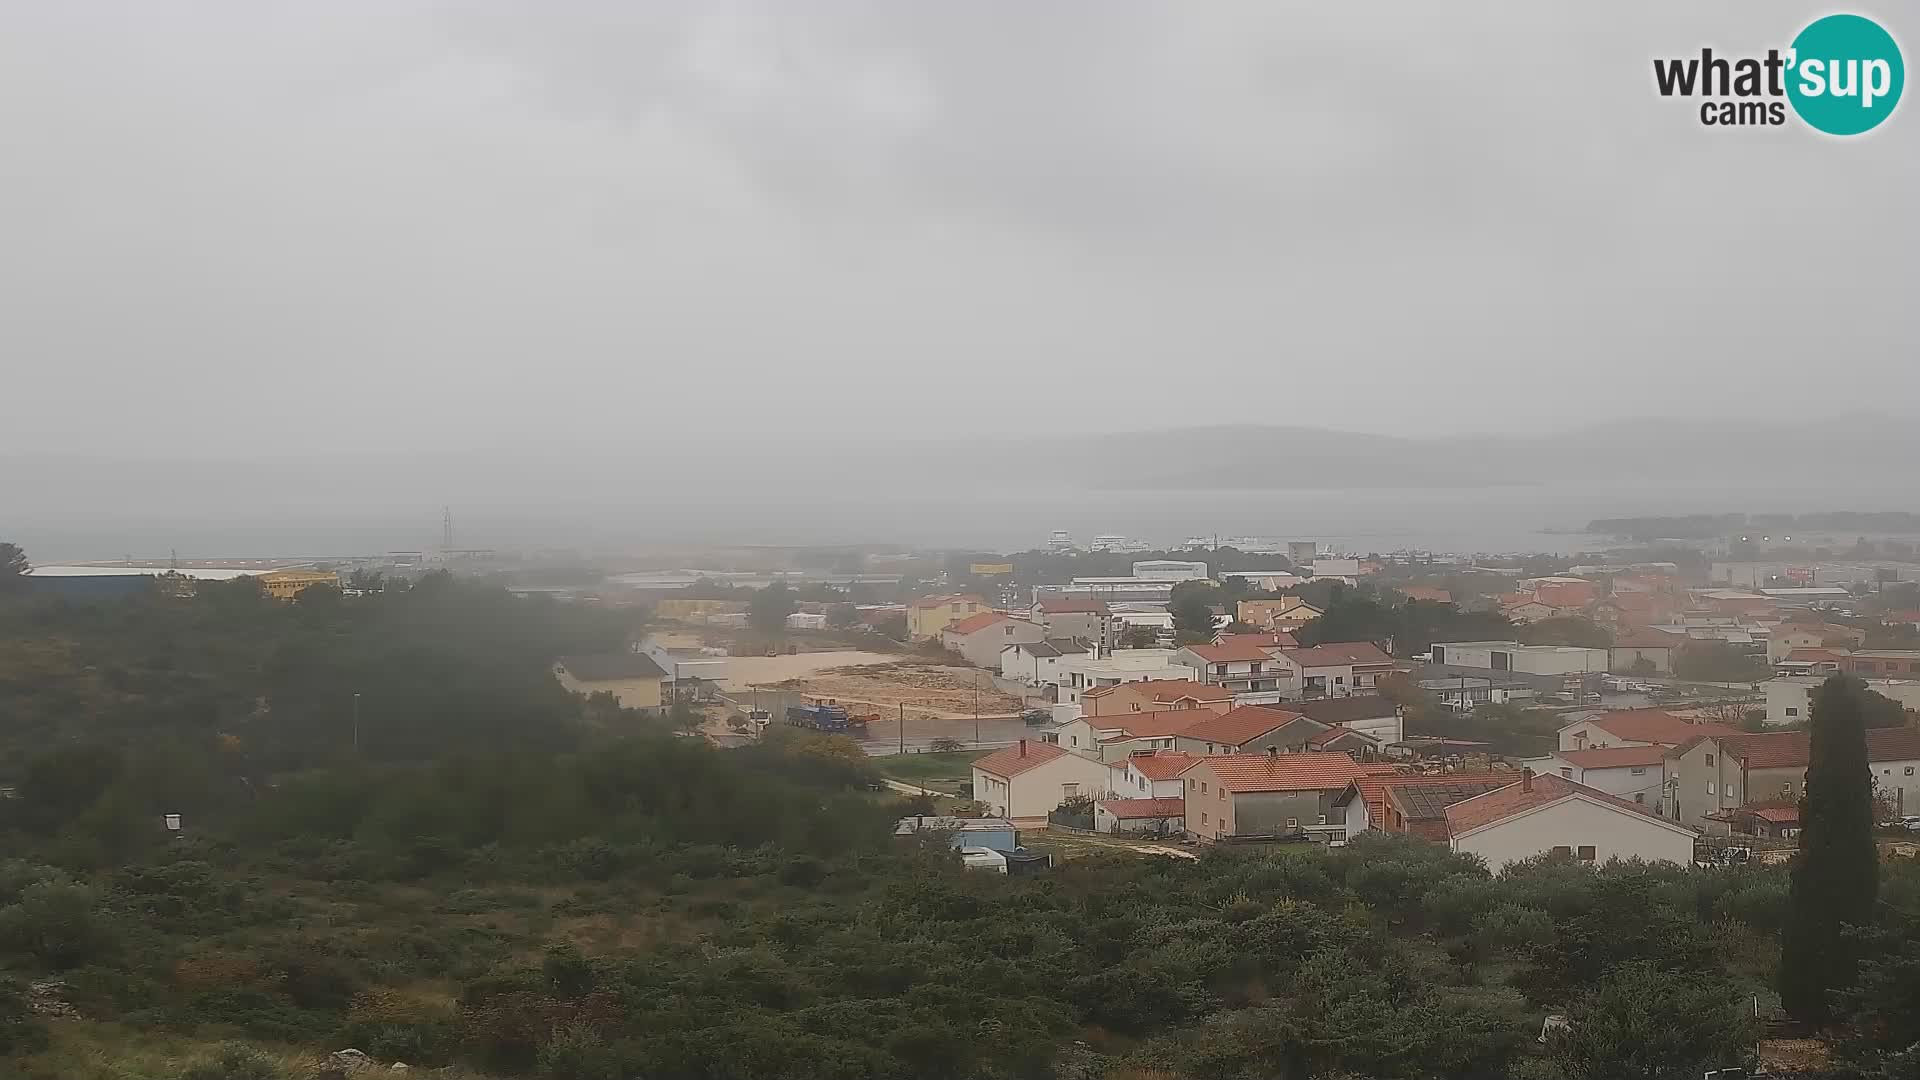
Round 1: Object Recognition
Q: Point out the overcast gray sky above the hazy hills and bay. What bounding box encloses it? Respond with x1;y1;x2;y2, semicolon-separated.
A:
0;0;1920;455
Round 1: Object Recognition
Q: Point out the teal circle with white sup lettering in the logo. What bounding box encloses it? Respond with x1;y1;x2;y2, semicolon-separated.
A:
1788;15;1907;135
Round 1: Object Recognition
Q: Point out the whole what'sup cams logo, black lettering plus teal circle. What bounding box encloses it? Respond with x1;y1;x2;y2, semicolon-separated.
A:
1653;15;1907;135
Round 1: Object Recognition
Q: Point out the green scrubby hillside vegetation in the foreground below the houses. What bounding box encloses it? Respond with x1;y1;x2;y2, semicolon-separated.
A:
0;568;1920;1080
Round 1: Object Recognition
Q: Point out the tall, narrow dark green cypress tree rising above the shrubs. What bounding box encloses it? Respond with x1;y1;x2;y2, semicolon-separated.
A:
1780;675;1880;1022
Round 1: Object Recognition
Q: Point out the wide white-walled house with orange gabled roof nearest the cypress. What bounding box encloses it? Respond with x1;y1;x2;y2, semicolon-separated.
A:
1446;771;1695;874
